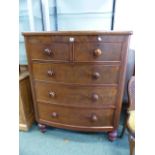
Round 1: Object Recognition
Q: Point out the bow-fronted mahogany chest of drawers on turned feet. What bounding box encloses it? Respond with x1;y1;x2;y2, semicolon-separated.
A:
23;31;131;140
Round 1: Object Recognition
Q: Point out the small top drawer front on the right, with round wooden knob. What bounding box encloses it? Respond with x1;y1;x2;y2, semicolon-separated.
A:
74;42;122;61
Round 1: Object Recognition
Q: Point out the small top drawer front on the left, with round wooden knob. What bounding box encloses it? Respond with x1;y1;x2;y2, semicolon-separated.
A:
28;36;71;61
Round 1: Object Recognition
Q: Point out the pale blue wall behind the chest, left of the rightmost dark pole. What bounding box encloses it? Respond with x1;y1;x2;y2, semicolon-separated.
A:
19;0;113;64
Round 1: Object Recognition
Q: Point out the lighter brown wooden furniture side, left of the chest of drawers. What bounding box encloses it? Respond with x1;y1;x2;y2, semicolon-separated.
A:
19;71;34;131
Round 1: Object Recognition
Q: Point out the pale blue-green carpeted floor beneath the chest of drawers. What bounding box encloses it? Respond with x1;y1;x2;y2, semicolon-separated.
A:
19;117;129;155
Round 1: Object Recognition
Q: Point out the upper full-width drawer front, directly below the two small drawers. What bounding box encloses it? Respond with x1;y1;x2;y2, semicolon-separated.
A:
33;63;119;84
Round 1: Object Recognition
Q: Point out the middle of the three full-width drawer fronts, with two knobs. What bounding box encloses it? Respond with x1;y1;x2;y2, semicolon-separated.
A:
35;82;117;107
